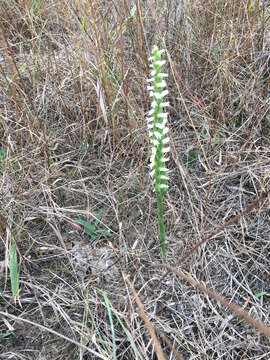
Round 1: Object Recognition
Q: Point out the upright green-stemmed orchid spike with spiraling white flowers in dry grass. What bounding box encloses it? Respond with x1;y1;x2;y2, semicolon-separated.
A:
147;46;170;257
